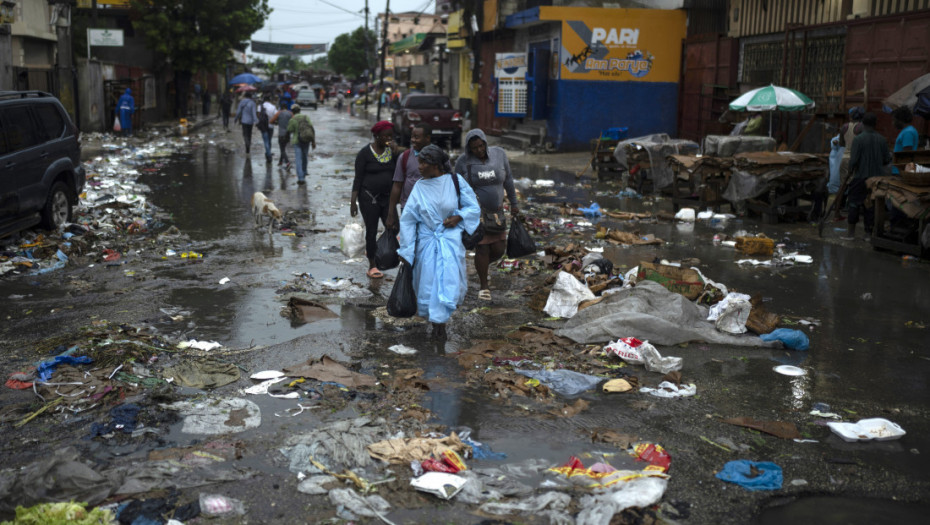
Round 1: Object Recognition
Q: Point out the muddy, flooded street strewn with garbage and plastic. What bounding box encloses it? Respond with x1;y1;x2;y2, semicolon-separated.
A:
0;107;930;524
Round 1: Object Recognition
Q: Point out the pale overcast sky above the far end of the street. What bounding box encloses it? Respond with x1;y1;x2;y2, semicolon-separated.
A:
247;0;436;60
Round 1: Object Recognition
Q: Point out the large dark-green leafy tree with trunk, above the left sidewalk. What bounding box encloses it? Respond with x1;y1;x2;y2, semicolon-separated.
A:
131;0;271;115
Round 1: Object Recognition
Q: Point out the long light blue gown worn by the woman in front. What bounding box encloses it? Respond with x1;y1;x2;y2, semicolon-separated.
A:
397;173;481;323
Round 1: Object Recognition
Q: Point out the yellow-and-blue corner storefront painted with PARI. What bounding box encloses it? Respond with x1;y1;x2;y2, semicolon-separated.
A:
504;6;687;150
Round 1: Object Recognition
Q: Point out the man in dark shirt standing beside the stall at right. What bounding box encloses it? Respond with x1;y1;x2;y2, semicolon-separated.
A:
844;112;891;240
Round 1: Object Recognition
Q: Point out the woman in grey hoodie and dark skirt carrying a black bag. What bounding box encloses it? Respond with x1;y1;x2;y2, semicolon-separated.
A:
454;129;520;301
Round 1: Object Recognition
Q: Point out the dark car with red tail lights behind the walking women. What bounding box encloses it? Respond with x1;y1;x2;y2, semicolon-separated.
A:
391;93;462;148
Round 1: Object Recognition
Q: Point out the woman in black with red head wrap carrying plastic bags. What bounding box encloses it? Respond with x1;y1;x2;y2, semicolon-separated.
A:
349;120;397;279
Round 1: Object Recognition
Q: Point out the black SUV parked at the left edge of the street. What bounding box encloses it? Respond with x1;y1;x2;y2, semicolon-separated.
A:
0;91;86;237
